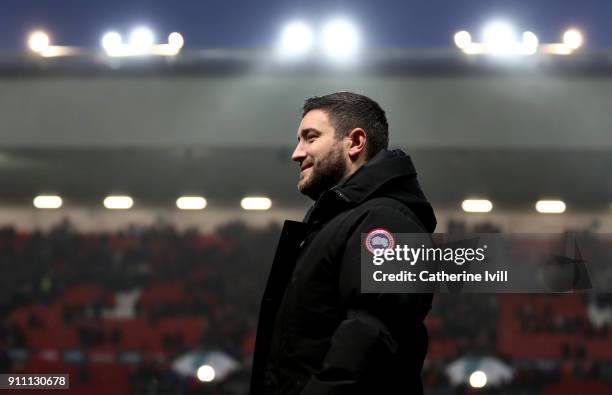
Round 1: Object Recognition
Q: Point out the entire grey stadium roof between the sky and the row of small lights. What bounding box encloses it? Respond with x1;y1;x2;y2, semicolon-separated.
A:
0;50;612;210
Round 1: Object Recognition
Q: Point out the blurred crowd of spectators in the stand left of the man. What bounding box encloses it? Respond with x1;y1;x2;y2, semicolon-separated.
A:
0;223;280;394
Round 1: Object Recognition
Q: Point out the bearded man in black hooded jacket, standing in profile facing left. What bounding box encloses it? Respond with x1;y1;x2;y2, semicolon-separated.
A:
251;92;436;395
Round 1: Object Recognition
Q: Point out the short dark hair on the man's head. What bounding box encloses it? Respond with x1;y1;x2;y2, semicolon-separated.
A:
302;92;389;159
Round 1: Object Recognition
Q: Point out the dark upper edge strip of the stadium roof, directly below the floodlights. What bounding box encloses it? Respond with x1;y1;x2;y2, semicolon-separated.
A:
0;48;612;77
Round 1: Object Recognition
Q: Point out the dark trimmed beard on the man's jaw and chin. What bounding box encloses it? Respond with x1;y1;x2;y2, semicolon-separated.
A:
300;147;347;201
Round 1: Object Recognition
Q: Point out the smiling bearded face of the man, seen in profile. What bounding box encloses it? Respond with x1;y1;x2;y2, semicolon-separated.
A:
291;110;348;200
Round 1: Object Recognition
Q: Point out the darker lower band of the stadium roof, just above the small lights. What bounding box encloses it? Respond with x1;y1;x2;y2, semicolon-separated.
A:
0;146;612;211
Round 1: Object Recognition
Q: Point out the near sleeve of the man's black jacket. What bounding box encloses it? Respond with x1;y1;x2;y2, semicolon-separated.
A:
302;206;431;395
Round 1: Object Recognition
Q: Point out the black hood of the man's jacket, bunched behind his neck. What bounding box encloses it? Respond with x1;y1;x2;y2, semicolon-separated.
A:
306;150;437;232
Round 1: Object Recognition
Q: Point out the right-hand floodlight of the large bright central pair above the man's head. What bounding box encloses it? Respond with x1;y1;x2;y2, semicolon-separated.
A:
322;19;360;62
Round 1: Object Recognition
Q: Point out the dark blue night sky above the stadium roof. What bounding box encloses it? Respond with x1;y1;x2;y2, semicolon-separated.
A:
0;0;612;51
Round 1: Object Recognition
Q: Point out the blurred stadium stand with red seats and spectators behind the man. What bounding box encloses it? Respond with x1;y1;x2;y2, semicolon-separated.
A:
0;223;612;395
